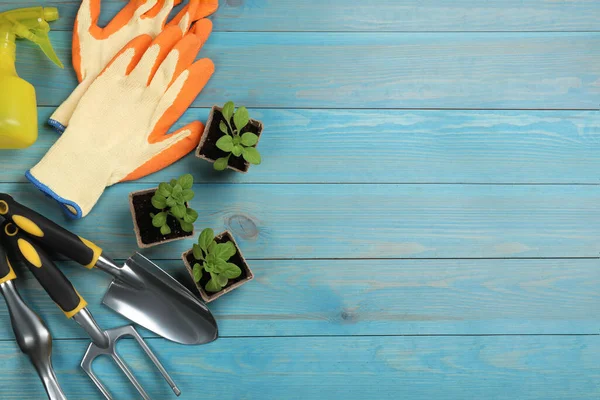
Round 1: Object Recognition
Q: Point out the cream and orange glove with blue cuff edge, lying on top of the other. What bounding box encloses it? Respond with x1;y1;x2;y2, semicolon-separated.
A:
26;20;214;218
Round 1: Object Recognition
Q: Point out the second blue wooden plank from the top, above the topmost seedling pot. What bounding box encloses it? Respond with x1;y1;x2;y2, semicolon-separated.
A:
12;31;600;110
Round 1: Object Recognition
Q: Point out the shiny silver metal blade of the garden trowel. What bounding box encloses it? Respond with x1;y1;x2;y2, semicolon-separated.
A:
102;253;219;344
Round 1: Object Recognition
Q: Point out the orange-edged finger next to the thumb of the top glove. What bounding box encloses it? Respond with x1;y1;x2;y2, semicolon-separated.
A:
148;58;215;143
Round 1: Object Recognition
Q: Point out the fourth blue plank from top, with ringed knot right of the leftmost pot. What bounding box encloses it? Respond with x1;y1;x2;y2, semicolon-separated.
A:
0;184;600;259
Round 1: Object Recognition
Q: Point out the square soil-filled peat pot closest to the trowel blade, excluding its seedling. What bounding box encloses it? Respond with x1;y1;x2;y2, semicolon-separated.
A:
181;231;254;303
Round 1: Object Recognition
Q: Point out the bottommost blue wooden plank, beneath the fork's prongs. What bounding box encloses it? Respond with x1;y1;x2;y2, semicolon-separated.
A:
0;336;600;400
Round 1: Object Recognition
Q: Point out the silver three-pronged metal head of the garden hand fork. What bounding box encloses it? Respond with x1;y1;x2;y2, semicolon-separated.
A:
81;325;181;400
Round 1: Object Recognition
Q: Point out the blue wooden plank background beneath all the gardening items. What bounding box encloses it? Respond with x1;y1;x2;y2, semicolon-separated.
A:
0;0;600;400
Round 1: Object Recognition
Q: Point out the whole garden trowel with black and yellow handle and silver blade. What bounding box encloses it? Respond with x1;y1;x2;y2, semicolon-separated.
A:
0;193;218;344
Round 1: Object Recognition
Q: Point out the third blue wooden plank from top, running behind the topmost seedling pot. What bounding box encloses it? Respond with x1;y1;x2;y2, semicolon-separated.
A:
0;107;600;184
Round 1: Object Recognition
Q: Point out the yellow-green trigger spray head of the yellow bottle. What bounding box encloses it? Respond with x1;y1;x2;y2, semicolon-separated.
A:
0;7;64;68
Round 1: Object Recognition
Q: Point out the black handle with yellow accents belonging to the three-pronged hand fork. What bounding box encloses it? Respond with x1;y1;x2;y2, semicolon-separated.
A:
5;222;87;318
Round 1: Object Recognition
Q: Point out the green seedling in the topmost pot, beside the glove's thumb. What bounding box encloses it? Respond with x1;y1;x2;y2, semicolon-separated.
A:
214;101;261;171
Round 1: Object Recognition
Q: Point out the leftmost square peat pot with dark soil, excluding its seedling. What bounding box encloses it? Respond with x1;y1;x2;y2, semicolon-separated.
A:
129;188;194;249
